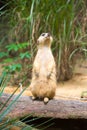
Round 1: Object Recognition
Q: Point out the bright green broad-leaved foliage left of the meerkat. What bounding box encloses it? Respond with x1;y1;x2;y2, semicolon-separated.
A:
1;42;31;74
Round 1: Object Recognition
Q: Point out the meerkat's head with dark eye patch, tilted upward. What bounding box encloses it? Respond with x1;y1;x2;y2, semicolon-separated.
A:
37;33;53;47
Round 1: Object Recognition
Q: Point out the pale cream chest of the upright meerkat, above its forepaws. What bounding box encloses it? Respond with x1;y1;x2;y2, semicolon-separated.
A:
34;48;54;75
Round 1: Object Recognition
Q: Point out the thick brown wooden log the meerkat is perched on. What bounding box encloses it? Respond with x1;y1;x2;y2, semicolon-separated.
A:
0;94;87;119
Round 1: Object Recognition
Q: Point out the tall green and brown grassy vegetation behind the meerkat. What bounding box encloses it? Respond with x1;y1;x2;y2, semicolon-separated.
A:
0;0;87;84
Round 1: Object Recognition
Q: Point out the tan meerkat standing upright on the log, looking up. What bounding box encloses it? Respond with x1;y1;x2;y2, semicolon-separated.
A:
30;33;56;103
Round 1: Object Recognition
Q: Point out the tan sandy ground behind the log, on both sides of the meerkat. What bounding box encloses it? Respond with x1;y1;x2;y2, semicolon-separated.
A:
1;60;87;100
